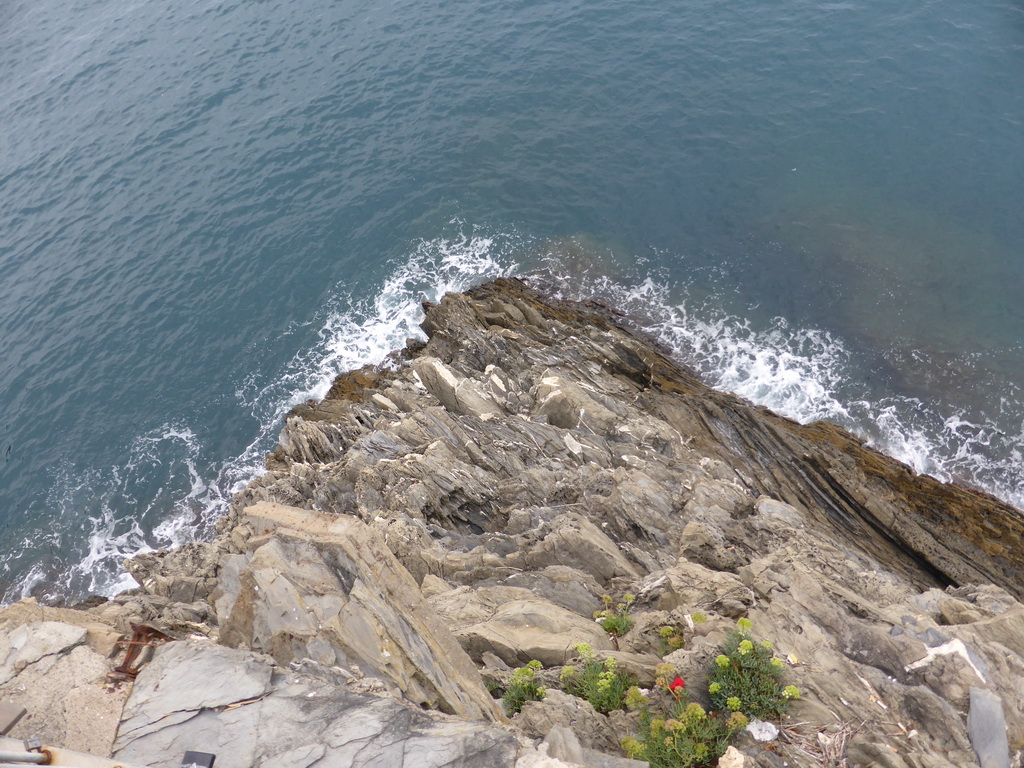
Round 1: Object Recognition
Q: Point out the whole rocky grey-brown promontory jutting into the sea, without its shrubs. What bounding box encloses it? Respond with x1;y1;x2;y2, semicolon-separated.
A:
0;280;1024;768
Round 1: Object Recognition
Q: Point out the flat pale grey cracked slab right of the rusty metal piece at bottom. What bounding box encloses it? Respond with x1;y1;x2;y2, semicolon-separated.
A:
116;642;517;768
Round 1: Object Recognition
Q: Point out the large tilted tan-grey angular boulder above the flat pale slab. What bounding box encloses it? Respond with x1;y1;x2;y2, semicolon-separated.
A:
220;503;503;720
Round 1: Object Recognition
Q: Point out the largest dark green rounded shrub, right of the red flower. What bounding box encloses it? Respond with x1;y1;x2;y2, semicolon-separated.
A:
708;618;800;720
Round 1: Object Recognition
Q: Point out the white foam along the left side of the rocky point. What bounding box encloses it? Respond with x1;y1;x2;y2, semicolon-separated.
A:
41;228;517;596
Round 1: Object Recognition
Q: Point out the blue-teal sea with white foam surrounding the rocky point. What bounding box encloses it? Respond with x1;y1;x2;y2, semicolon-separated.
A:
0;0;1024;600
